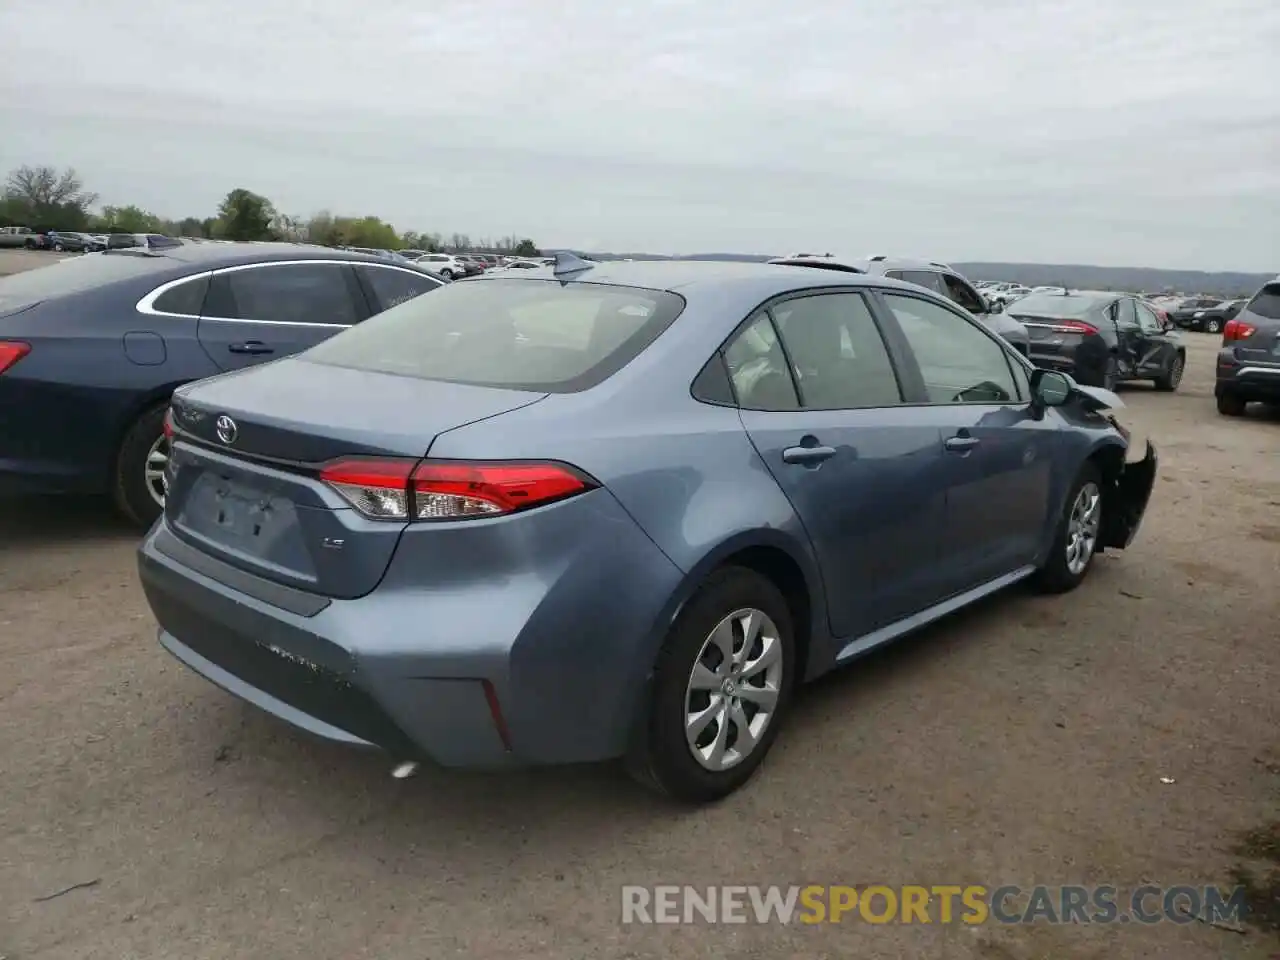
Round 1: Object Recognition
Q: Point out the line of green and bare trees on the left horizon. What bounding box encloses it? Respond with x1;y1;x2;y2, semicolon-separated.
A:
0;166;539;256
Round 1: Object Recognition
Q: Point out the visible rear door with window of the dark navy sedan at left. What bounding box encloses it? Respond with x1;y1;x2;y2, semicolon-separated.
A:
198;260;369;370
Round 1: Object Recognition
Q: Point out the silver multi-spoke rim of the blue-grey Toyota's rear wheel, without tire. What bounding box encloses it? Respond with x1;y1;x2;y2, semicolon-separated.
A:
685;607;783;772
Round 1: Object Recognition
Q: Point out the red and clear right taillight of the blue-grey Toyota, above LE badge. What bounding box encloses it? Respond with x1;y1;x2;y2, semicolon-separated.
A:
320;458;596;521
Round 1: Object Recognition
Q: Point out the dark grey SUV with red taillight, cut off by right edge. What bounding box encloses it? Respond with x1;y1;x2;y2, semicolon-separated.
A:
1213;276;1280;417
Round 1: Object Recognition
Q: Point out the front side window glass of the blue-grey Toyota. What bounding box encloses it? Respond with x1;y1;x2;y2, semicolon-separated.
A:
882;293;1019;403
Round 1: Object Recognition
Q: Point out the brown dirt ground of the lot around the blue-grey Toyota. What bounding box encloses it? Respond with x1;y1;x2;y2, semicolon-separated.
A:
0;252;1280;960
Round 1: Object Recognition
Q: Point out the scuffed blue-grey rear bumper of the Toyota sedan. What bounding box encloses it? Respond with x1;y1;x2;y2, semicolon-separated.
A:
138;490;681;768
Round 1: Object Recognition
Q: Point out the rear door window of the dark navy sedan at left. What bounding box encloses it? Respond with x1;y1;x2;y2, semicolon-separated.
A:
205;264;360;326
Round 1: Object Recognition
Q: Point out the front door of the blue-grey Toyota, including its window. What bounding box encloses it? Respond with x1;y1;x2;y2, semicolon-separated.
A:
878;291;1056;596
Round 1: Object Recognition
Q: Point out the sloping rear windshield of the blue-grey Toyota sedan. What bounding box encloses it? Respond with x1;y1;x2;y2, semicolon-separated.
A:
303;279;685;393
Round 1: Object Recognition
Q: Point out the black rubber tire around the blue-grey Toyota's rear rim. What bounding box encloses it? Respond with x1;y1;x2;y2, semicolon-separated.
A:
627;567;796;804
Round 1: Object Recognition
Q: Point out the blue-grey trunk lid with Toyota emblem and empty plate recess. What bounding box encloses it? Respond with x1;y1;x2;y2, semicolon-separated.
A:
165;358;545;599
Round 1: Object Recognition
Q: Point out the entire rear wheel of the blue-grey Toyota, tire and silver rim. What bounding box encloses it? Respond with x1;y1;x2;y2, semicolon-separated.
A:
627;567;796;803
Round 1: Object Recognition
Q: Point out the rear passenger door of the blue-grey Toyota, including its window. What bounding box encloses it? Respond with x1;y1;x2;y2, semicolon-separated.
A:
724;292;945;637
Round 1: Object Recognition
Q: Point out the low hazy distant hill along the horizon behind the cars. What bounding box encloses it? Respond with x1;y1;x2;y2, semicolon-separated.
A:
585;253;1276;297
